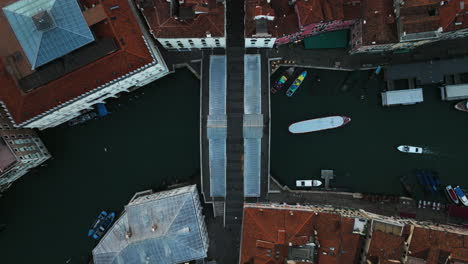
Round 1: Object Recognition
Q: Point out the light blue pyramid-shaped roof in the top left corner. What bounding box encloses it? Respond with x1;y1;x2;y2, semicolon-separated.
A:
3;0;94;69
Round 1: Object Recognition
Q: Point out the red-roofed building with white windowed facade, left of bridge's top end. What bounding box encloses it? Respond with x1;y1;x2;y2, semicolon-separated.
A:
136;0;226;51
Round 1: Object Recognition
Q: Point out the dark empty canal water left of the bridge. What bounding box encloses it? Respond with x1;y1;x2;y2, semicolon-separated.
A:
0;70;200;264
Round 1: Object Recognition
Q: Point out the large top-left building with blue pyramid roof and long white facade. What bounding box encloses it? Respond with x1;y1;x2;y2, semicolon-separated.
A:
0;0;169;129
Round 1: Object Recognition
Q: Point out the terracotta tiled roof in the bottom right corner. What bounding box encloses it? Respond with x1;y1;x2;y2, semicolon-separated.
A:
409;227;468;263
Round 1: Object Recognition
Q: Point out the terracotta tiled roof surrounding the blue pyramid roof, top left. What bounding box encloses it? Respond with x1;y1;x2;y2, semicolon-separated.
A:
0;0;153;124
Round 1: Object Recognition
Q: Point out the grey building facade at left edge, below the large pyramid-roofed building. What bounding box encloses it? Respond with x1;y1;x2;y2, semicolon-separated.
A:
0;110;50;193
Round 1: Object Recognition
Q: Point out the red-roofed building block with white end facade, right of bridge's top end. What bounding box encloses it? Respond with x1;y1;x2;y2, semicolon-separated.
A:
245;0;360;48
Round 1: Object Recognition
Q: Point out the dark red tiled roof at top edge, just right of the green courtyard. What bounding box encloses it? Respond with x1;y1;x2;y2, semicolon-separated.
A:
361;0;398;46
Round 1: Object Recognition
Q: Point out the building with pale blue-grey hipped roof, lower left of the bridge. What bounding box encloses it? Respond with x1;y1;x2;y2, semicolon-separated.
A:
93;185;208;264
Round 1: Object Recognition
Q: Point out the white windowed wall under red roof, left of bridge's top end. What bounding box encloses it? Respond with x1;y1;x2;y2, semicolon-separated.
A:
158;37;226;50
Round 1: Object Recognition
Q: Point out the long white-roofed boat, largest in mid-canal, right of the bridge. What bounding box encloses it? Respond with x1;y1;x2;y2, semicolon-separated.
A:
289;116;351;134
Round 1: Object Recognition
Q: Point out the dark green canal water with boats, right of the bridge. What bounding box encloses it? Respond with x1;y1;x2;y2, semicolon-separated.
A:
271;69;468;195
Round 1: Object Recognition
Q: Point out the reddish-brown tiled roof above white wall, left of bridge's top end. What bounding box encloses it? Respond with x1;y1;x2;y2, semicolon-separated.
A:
137;0;224;38
